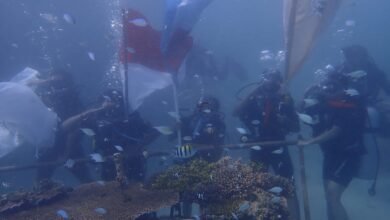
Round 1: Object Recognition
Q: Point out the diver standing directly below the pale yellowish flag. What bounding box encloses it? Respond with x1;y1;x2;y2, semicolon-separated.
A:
233;69;299;219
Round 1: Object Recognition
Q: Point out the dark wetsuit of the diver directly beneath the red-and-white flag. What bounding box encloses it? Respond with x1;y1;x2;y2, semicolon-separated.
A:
93;112;158;181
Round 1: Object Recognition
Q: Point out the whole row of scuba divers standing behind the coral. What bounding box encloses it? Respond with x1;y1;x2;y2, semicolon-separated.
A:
3;45;390;220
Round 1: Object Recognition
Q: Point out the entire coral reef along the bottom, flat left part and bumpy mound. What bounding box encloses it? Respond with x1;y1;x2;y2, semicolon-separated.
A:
0;157;294;220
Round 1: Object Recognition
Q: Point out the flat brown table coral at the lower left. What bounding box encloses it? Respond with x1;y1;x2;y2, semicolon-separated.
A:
0;181;179;220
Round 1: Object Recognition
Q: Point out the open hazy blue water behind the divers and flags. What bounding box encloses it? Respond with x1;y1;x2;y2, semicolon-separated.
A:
0;0;390;220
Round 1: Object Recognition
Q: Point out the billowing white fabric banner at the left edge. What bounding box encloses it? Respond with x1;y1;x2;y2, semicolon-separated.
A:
0;82;58;158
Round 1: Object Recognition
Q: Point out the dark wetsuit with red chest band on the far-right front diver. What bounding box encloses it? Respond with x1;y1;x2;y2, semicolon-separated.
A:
305;86;367;187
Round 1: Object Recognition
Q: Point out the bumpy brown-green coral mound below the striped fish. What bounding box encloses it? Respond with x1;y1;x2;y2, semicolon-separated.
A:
151;157;294;220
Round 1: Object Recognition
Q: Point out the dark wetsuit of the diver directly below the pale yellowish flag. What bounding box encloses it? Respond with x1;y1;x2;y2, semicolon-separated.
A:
239;92;299;179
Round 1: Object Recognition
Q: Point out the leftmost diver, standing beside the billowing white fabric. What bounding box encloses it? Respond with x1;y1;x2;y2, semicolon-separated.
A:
35;70;92;183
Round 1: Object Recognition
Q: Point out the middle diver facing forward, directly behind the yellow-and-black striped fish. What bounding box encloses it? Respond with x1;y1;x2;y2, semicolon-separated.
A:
171;96;226;218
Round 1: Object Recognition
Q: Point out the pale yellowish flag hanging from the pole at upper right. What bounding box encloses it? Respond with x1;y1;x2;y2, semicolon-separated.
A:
283;0;342;80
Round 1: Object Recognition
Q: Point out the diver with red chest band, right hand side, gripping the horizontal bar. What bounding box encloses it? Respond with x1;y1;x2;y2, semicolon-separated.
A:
298;72;367;220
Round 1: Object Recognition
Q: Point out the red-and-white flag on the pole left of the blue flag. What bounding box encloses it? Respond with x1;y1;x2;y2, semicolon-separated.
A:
121;9;193;110
